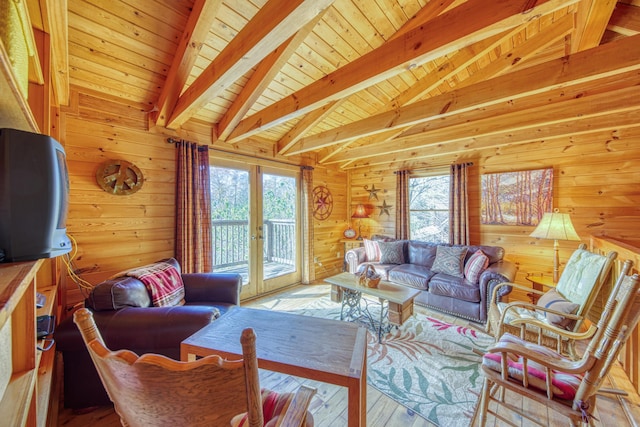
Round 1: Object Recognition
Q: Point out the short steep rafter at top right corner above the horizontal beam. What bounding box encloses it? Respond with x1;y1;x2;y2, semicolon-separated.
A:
571;0;617;53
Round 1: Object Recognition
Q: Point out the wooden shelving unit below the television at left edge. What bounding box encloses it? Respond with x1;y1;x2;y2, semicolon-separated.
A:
0;259;61;426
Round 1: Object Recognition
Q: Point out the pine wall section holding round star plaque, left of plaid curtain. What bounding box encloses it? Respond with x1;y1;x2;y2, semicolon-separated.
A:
61;90;180;305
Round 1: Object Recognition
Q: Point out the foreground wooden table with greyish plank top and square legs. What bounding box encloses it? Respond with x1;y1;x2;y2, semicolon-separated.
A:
180;307;367;427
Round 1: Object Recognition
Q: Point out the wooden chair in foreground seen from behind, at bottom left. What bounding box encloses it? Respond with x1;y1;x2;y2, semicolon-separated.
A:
73;309;315;427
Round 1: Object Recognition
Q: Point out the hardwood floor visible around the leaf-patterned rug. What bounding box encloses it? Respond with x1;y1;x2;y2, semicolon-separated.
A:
58;284;640;427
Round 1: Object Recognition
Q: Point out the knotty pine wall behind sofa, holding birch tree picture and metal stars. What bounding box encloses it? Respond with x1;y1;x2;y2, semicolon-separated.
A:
350;127;640;300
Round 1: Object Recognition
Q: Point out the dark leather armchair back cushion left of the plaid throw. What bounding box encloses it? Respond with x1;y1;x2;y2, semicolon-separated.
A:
85;277;151;311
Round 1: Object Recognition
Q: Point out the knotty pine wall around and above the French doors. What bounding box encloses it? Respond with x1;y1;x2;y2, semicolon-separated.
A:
59;87;348;306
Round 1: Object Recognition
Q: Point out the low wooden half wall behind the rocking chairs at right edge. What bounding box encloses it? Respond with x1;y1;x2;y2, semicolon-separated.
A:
589;236;640;392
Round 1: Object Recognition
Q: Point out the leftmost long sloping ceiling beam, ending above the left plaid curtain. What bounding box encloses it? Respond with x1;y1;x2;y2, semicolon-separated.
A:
155;0;222;126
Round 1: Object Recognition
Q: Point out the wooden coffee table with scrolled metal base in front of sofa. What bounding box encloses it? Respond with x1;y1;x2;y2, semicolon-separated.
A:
324;273;420;342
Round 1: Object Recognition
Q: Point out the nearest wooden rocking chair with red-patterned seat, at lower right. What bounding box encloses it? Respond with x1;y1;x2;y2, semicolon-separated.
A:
472;266;640;427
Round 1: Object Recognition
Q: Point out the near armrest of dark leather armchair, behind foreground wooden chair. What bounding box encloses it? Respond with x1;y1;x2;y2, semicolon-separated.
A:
54;305;215;354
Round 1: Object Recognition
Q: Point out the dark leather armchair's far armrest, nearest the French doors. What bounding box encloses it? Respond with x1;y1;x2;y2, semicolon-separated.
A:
182;273;242;305
